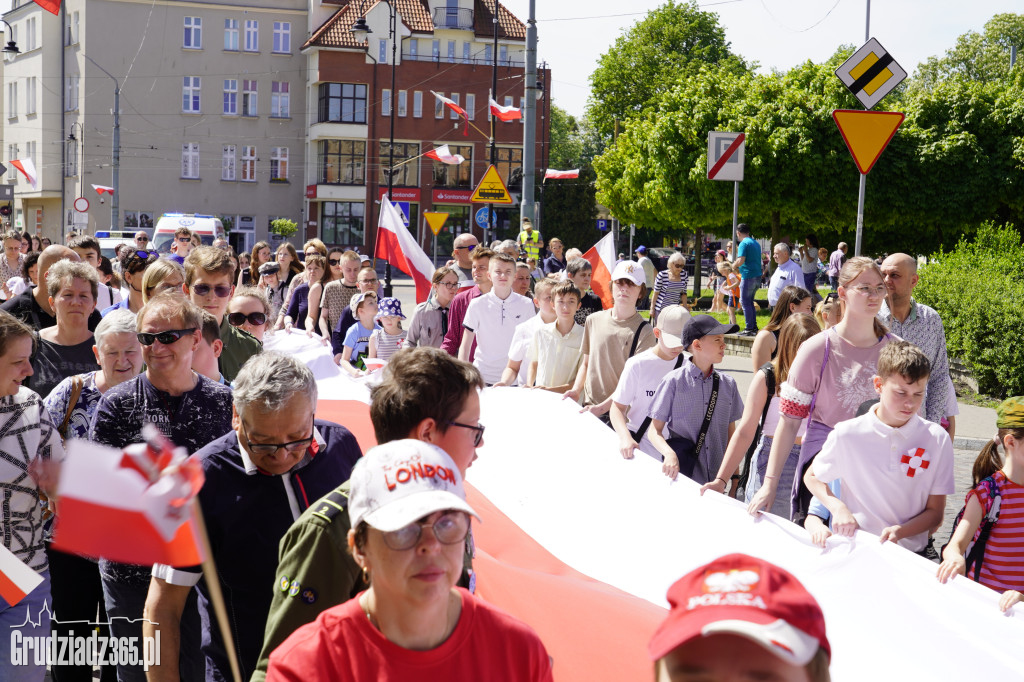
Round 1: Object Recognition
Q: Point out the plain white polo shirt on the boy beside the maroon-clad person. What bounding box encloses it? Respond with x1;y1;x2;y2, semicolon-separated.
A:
462;291;537;384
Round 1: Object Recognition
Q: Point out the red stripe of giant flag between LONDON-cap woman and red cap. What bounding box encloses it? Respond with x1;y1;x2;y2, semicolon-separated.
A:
466;483;667;682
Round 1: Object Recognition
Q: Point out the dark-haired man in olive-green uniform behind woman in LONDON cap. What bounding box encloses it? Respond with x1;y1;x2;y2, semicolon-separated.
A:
252;346;484;682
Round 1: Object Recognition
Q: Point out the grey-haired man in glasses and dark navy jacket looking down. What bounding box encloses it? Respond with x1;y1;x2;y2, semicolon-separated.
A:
143;352;362;682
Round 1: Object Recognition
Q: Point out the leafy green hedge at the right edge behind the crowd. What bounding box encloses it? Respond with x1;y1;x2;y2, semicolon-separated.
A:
914;222;1024;397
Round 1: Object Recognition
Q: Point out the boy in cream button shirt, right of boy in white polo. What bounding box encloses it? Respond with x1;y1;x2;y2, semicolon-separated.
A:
526;282;583;393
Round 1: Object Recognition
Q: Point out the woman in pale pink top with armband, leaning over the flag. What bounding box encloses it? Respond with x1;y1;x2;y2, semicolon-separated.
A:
746;257;895;523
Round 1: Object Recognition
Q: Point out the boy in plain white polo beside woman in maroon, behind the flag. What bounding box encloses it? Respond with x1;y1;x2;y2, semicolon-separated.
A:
459;254;536;385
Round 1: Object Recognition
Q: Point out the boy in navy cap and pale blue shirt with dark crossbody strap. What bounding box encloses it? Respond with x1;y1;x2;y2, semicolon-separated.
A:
647;315;743;485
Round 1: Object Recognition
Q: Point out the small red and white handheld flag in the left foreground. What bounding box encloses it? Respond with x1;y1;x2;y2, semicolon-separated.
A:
53;425;203;566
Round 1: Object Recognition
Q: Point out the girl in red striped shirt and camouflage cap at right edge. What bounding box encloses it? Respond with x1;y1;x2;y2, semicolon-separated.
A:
938;395;1024;611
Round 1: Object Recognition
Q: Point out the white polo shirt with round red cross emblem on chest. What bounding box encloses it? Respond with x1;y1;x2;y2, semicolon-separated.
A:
812;406;956;552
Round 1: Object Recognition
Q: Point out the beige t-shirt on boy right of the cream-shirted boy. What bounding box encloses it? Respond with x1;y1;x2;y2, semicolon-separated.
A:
581;309;657;404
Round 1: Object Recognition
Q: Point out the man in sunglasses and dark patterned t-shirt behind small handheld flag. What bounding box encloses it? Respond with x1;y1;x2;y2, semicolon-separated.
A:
89;296;231;681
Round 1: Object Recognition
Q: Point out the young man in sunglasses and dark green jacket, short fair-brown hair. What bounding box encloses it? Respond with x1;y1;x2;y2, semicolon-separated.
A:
182;246;263;383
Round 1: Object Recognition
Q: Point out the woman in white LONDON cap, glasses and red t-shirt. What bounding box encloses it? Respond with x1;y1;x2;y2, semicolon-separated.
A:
266;440;552;682
